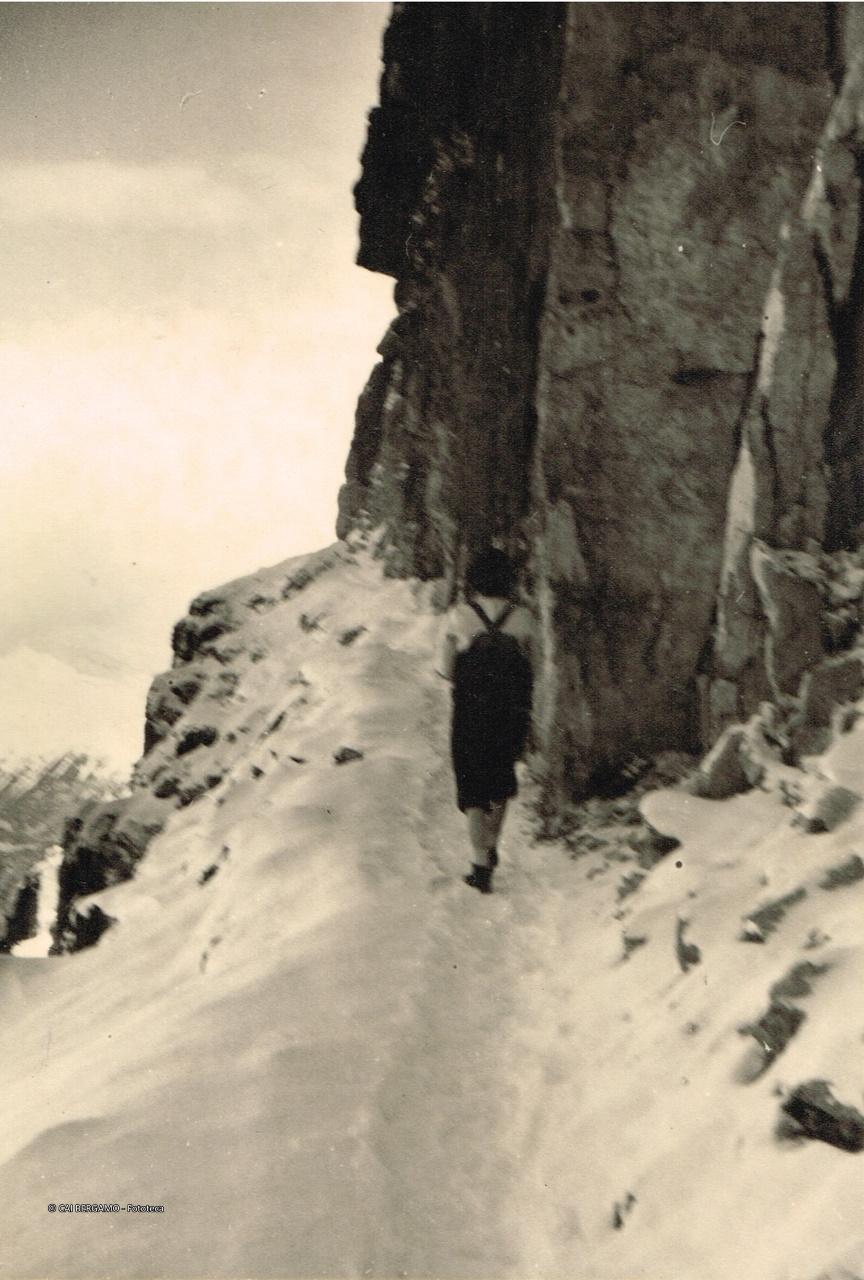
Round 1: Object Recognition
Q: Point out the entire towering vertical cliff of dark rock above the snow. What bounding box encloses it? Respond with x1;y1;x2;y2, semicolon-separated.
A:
339;4;864;791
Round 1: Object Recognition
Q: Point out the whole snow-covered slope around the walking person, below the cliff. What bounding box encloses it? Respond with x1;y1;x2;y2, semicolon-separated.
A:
0;547;864;1280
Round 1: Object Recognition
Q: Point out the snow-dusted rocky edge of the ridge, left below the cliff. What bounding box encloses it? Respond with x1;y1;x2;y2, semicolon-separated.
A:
53;547;350;951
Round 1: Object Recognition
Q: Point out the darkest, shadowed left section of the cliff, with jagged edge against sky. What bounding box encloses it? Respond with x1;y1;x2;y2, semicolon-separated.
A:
339;4;564;576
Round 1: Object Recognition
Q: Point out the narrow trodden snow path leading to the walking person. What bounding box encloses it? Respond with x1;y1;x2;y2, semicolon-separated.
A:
364;675;591;1280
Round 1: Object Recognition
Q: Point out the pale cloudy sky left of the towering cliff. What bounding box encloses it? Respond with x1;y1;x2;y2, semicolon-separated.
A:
0;3;393;755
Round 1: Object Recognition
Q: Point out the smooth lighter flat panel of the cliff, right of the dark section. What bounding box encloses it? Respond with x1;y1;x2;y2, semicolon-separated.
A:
534;5;827;776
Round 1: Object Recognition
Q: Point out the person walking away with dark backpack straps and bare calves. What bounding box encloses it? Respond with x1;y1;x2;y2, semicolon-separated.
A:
438;548;536;893
